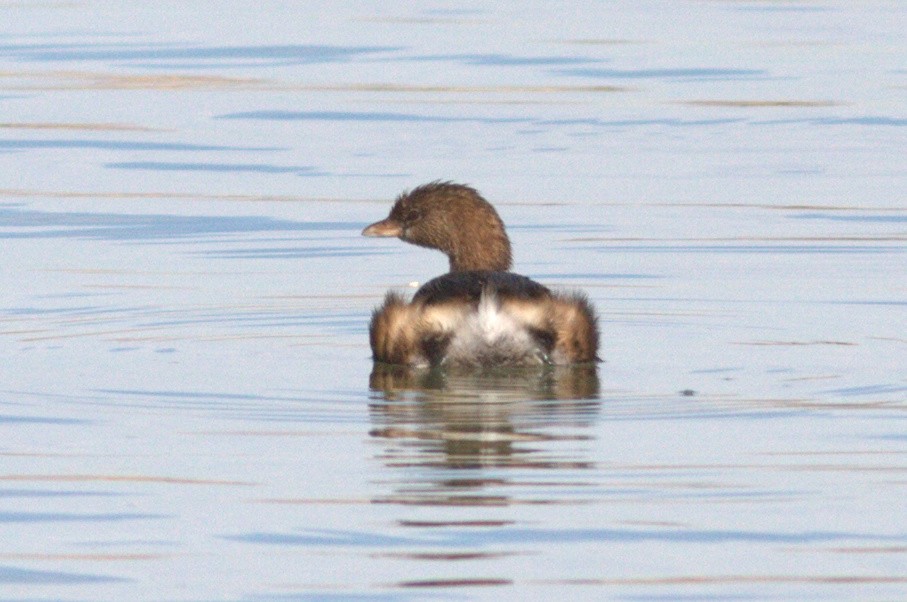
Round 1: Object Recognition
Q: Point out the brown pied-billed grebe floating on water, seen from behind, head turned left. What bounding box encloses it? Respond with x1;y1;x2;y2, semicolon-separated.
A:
362;182;598;367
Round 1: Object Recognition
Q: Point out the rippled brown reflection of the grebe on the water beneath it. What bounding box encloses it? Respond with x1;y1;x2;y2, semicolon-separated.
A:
369;362;600;505
